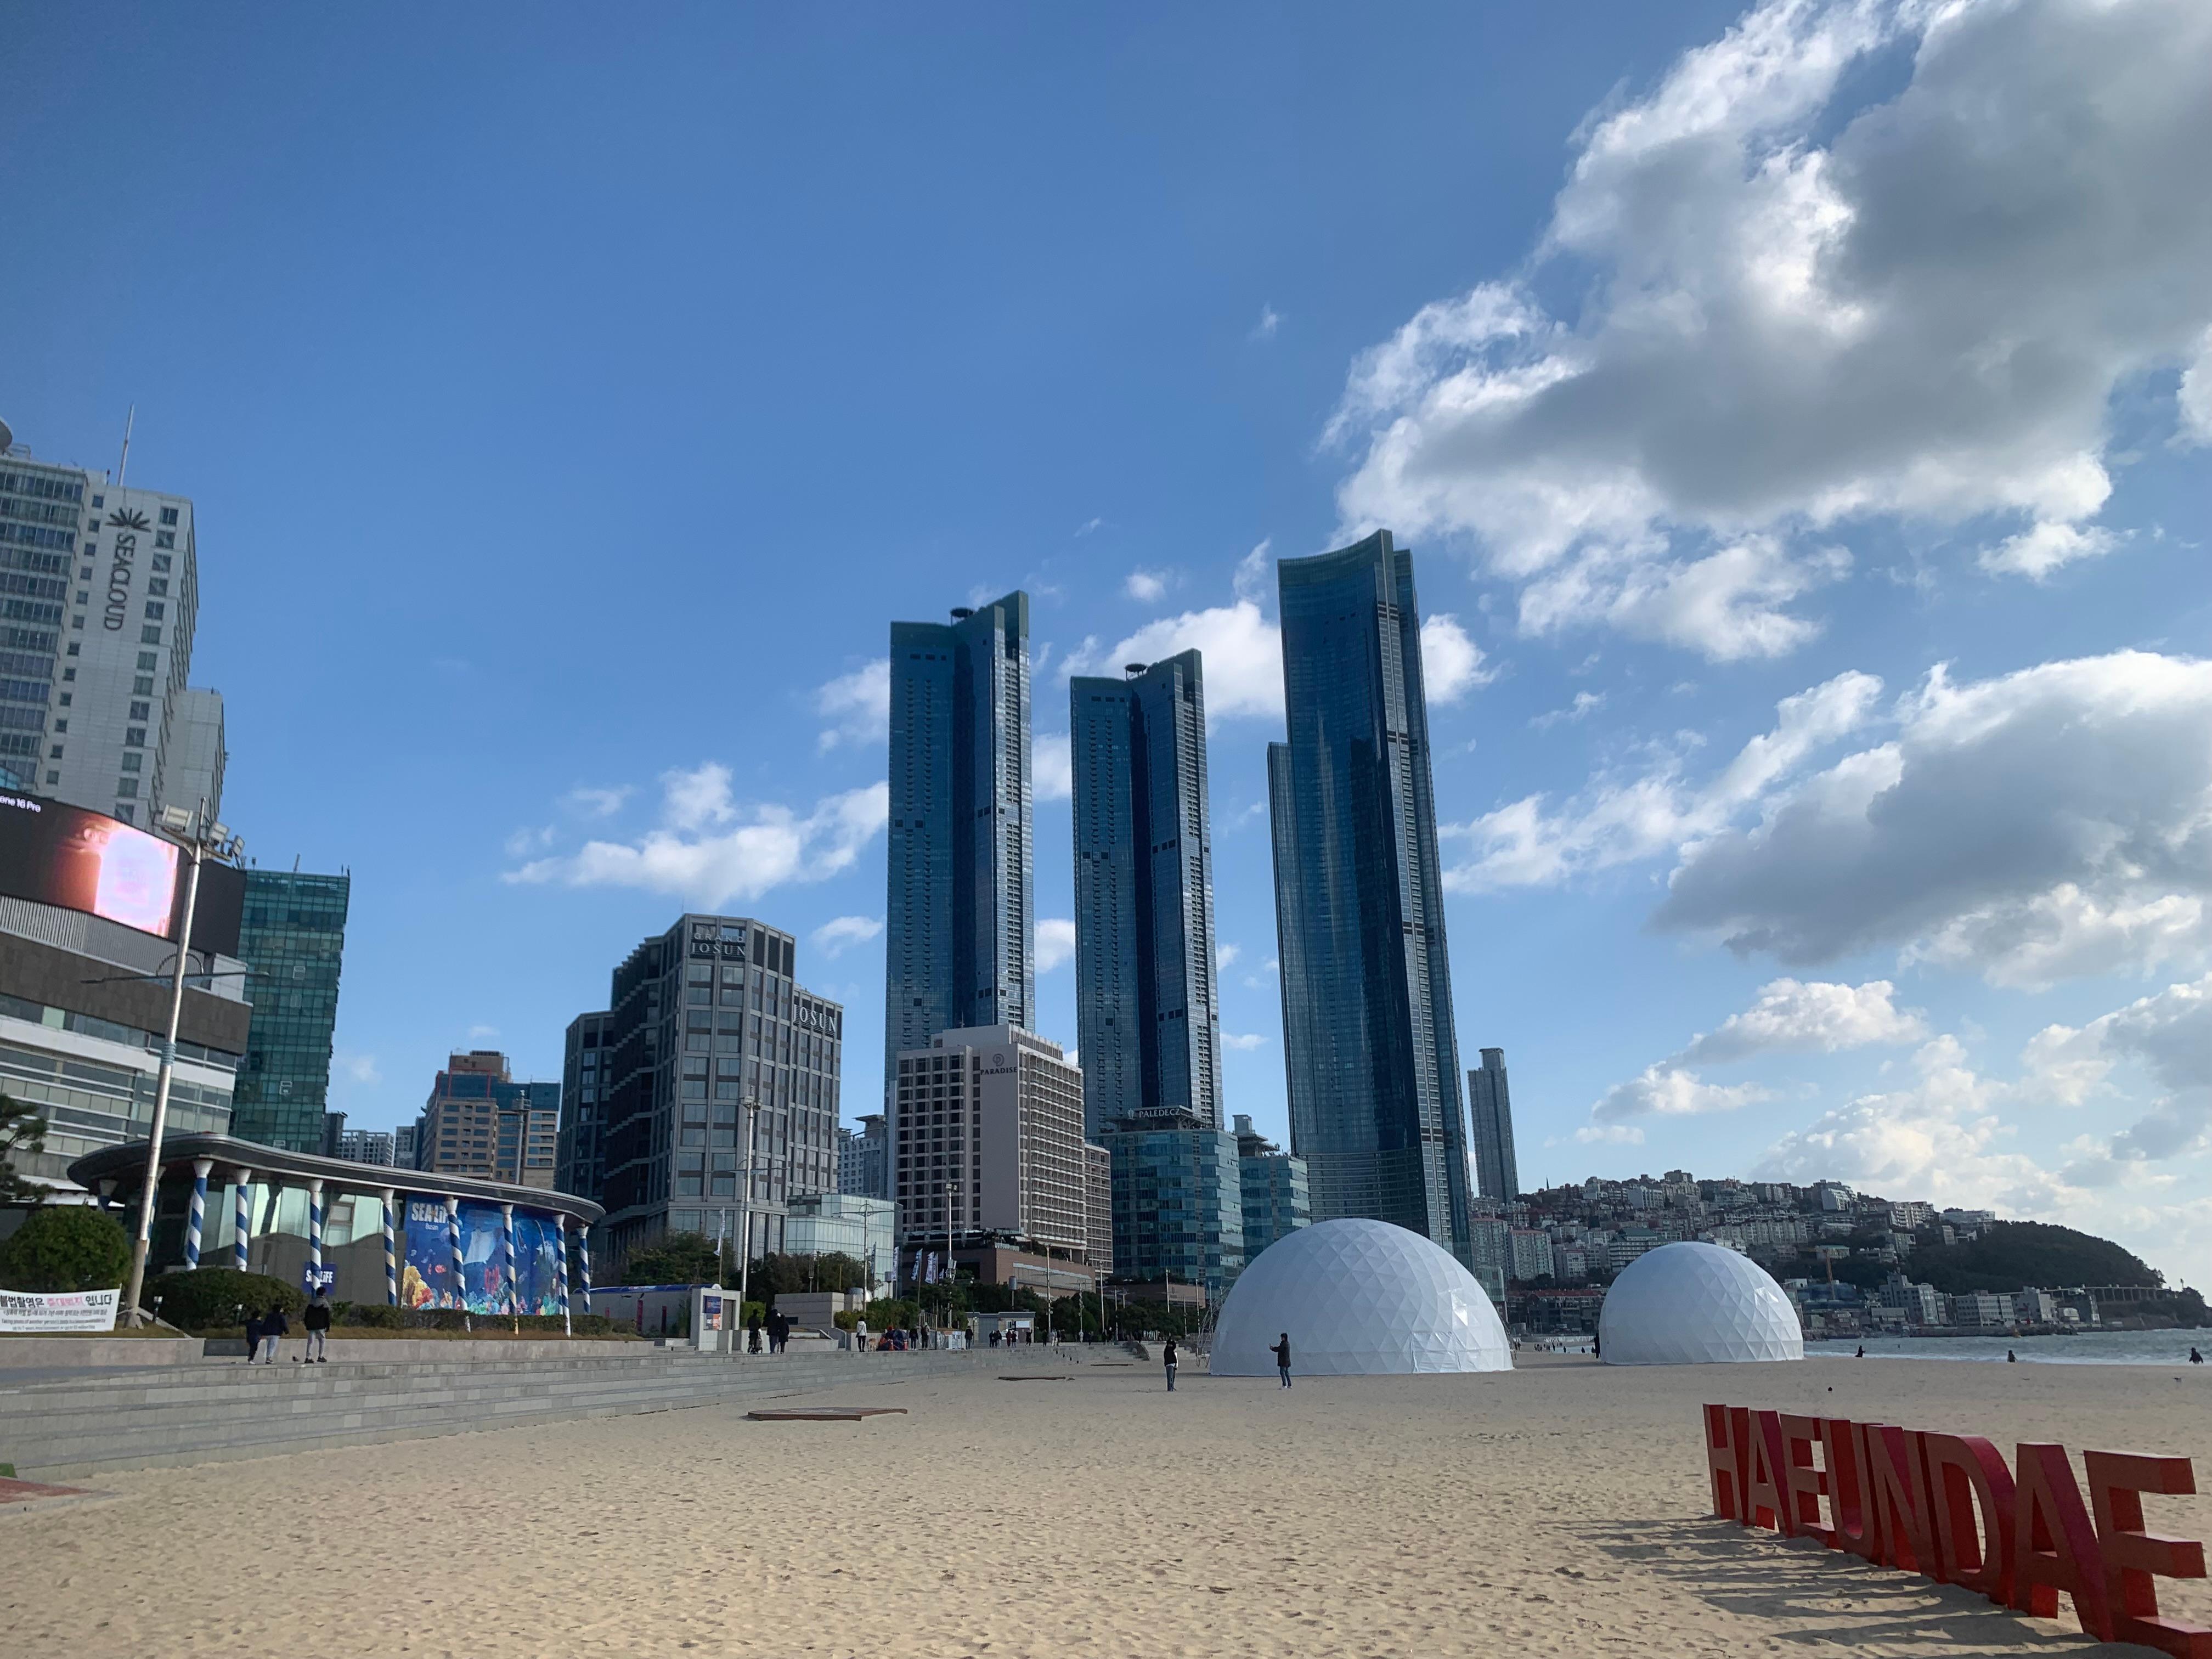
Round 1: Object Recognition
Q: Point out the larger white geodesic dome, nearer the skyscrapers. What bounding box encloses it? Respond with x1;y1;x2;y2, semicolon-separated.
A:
1212;1221;1513;1376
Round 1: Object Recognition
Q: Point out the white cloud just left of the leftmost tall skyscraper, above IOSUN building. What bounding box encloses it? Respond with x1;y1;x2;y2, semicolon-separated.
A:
502;761;889;909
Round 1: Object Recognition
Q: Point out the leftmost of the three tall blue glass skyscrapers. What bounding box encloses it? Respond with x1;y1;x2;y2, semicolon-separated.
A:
883;593;1037;1091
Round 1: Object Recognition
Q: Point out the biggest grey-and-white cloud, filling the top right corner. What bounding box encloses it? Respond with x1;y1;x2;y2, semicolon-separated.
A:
1329;0;2212;659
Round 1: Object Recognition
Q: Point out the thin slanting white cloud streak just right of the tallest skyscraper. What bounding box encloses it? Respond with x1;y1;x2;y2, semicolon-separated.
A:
1444;673;1882;894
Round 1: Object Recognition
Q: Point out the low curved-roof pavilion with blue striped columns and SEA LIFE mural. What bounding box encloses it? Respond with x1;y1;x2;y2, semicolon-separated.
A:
69;1135;604;1314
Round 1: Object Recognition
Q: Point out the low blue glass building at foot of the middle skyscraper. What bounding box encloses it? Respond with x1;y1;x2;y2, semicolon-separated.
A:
1102;1106;1245;1303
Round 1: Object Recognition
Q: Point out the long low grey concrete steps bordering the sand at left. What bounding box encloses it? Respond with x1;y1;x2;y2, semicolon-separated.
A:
0;1350;1007;1480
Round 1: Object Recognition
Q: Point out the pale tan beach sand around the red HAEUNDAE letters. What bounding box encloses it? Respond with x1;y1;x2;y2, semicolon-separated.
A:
0;1354;2212;1659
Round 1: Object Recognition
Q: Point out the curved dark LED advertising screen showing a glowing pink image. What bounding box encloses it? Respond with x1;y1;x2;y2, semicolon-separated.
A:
0;792;246;956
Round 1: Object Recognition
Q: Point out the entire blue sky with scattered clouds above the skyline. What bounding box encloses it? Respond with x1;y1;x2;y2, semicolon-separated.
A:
0;0;2212;1276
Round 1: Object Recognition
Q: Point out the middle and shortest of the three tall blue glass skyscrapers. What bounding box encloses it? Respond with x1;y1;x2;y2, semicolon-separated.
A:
1068;650;1221;1137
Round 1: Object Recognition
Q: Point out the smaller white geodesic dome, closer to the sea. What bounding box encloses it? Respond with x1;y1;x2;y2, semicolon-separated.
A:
1597;1243;1805;1365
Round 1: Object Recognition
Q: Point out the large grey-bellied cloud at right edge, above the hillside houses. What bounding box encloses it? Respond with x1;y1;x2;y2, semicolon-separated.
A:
1655;652;2212;986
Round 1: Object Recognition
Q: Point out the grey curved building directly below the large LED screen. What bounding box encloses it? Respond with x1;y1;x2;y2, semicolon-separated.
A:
0;872;252;1190
